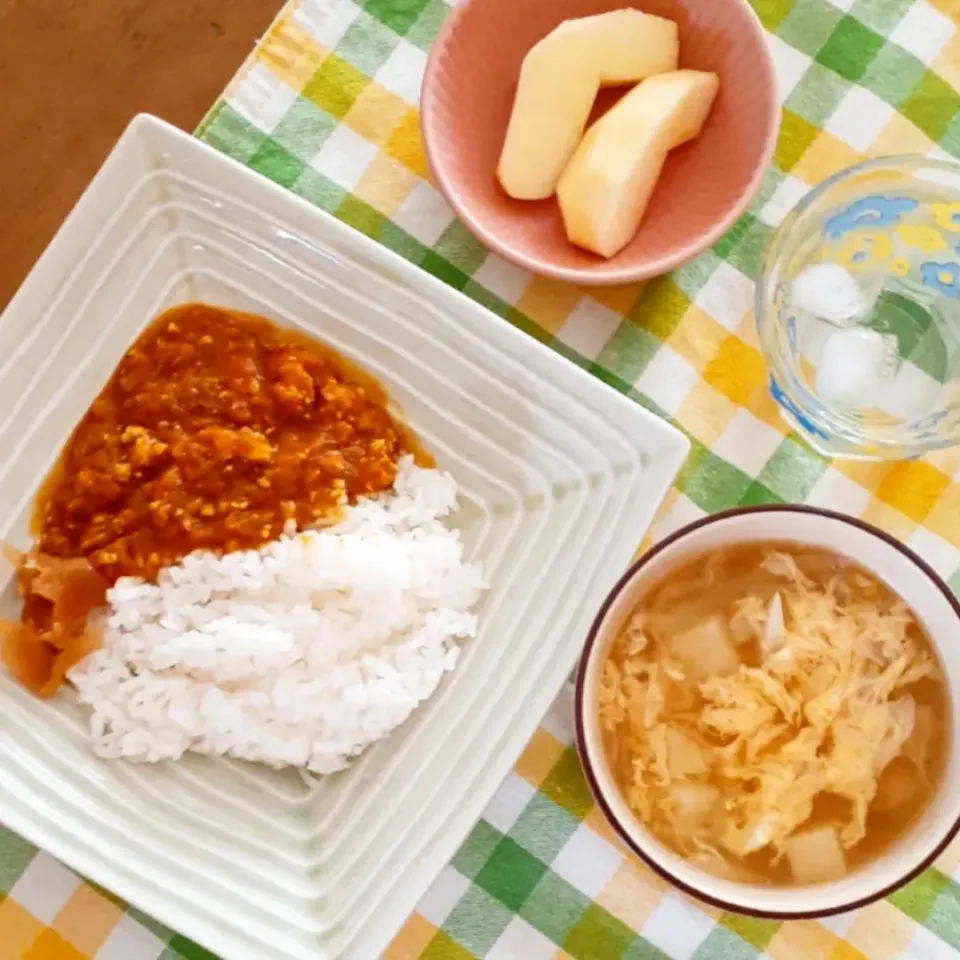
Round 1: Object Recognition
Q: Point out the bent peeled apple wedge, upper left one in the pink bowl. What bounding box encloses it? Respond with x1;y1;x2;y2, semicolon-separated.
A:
497;10;679;200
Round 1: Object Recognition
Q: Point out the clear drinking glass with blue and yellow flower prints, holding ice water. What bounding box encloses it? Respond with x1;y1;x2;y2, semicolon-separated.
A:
756;156;960;459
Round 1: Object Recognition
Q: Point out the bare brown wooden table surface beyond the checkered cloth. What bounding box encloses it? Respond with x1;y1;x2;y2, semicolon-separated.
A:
0;0;281;309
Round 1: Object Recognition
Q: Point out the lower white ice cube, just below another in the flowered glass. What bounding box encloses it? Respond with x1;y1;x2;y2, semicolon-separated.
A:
816;327;898;410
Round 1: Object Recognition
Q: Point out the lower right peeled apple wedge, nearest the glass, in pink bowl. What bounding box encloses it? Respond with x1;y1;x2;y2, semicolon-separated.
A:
557;70;720;257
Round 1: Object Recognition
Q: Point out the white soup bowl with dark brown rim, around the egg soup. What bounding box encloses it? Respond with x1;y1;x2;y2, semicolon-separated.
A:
576;506;960;919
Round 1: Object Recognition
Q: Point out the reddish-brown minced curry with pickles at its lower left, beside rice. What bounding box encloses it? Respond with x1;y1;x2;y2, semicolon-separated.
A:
2;303;415;694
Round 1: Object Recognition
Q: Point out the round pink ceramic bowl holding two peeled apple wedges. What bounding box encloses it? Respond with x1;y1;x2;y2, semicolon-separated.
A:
421;0;780;285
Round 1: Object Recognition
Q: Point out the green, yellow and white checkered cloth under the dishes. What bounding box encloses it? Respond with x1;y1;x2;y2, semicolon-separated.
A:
0;0;960;960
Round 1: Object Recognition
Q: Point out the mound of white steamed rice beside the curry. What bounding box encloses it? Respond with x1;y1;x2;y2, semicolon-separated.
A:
69;458;483;774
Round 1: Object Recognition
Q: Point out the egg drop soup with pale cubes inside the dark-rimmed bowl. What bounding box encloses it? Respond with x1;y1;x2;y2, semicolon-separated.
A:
599;543;951;885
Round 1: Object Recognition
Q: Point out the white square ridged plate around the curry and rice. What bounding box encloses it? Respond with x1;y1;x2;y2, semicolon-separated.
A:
0;117;688;960
